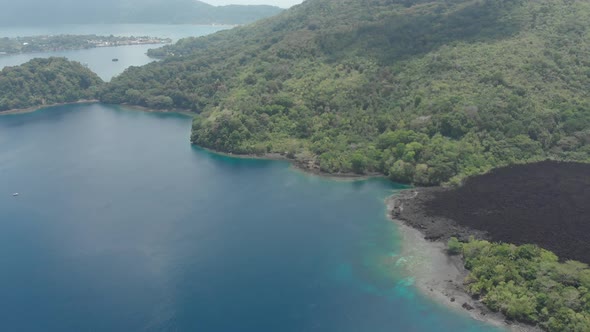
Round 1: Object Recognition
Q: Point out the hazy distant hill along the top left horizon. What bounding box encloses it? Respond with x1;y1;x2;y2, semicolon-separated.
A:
0;0;282;25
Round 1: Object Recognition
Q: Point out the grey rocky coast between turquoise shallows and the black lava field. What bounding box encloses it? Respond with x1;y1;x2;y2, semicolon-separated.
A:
386;187;542;332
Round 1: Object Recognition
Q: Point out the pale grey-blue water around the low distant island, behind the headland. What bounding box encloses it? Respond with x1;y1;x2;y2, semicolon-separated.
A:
0;24;230;81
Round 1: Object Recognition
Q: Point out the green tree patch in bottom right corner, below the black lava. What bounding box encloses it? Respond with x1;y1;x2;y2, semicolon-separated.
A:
449;238;590;332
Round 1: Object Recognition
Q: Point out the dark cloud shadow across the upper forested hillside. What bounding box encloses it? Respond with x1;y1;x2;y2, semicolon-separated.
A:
319;1;522;64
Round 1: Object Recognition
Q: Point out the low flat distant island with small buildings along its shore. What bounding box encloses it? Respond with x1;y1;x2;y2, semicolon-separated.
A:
0;35;172;55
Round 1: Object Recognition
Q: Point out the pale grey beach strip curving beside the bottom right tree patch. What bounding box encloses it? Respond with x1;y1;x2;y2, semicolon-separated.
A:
385;193;543;332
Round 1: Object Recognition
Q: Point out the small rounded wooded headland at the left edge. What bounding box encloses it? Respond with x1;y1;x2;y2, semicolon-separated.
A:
0;58;103;112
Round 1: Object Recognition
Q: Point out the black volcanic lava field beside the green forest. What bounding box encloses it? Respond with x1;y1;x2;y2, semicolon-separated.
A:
394;161;590;263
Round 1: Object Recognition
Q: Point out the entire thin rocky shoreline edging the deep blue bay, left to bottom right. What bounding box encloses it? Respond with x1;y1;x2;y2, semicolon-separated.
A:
0;100;542;332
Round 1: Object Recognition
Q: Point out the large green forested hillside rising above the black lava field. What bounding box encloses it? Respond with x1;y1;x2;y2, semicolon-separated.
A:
101;0;590;185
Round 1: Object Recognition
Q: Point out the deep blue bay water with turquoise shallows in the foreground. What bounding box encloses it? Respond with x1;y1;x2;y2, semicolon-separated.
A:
0;104;502;332
